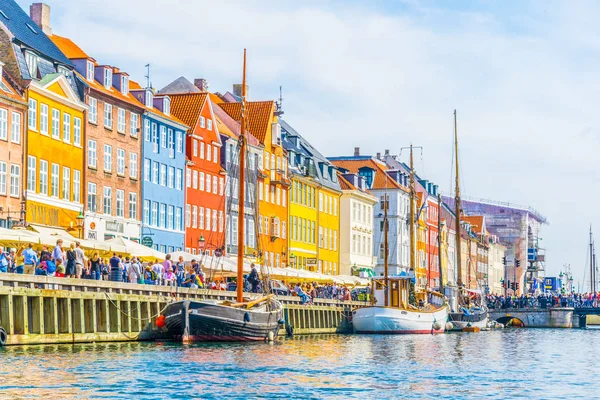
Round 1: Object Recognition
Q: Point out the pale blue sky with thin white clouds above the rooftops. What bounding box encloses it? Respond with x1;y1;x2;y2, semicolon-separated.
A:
18;0;600;283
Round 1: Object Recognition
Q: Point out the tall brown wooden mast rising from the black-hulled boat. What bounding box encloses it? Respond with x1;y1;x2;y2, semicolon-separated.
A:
237;49;246;303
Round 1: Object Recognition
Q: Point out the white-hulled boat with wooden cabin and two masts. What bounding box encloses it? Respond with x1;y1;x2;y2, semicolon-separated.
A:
352;145;448;334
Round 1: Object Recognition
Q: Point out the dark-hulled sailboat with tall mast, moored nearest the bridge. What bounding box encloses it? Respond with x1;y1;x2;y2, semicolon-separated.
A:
449;110;489;331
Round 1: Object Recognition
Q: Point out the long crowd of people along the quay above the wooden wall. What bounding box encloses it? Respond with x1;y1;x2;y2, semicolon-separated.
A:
0;239;357;304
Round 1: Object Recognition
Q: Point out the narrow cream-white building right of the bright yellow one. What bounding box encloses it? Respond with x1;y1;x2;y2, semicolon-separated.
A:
339;173;377;275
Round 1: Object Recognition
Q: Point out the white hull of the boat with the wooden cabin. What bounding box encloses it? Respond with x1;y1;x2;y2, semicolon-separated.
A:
352;306;448;334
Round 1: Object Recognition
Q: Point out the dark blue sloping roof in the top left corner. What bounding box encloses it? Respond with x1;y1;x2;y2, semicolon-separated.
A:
0;0;73;67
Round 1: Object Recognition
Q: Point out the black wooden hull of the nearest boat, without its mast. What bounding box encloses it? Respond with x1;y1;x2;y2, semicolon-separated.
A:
164;299;283;343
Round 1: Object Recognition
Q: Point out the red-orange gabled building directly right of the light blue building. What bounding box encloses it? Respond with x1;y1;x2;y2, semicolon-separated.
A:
164;80;225;256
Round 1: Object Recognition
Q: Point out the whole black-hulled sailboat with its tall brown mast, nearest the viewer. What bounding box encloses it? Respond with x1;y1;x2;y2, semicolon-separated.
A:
163;49;283;343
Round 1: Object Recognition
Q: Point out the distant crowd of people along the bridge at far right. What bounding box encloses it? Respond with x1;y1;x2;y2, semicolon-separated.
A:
487;292;600;309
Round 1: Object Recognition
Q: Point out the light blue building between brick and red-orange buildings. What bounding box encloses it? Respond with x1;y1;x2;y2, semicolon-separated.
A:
130;82;189;253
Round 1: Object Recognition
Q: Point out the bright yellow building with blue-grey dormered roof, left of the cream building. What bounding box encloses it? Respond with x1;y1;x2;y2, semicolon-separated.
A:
279;119;342;275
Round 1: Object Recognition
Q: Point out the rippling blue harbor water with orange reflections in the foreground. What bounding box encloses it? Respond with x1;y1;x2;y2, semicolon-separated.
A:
0;328;600;399
